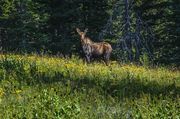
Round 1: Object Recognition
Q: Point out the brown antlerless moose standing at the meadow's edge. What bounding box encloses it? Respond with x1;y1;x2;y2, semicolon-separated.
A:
76;28;112;66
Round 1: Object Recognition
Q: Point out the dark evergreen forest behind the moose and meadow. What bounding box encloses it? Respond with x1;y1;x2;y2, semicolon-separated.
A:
0;0;180;65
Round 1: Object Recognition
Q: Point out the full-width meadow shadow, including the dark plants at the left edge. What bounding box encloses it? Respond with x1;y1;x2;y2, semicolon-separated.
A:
0;57;180;99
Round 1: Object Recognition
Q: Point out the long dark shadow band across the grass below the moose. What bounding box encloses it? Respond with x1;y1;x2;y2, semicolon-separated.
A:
24;73;180;99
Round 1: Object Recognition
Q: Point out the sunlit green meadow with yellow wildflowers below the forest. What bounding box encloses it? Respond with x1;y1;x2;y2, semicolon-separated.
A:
0;55;180;119
